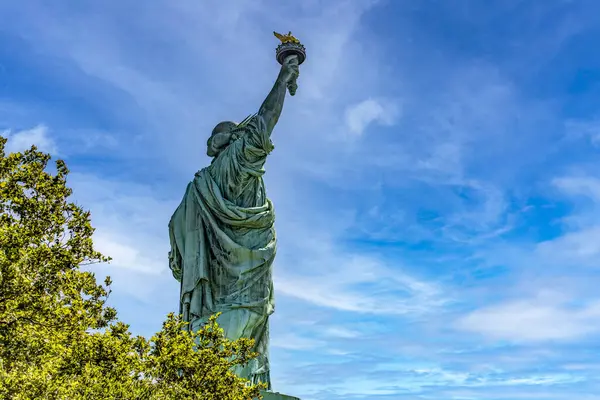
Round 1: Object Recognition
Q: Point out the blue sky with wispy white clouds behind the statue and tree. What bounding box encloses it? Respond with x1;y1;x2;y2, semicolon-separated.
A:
0;0;600;400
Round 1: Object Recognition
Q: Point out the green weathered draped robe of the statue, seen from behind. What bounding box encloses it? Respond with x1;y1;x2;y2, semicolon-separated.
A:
169;115;276;388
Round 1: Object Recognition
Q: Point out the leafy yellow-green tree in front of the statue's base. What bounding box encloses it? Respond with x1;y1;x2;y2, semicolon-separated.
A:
0;137;264;400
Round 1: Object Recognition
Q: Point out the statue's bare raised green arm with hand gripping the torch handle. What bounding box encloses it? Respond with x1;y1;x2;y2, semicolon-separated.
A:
258;56;298;135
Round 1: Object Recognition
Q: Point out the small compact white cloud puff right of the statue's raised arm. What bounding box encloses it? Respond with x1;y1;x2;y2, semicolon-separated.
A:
345;98;399;136
